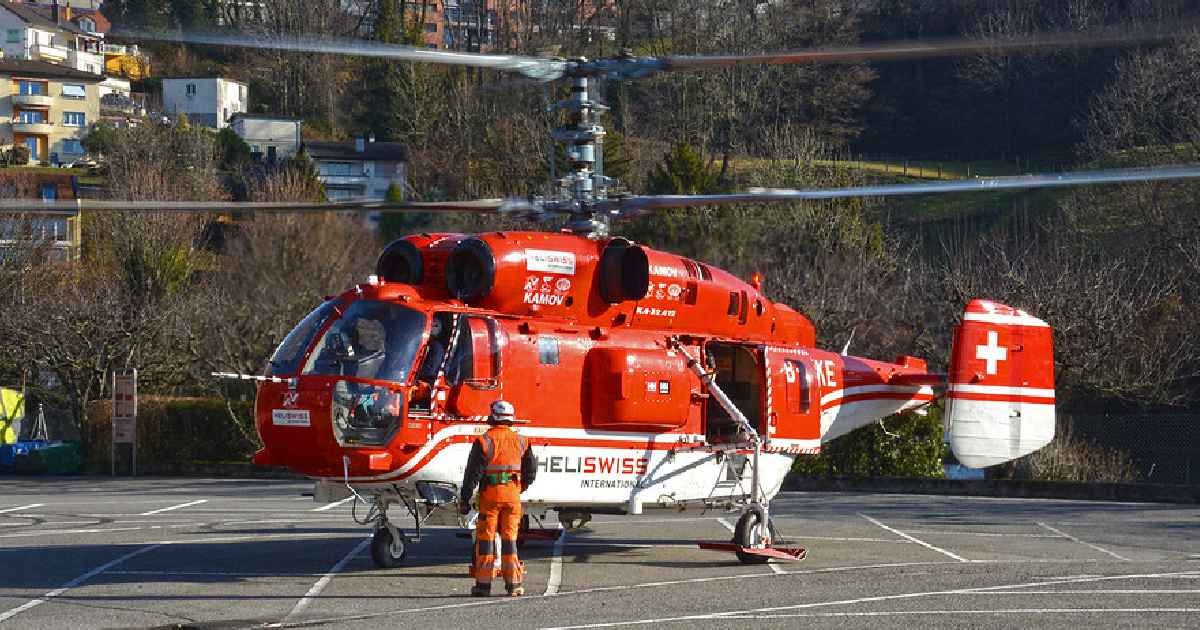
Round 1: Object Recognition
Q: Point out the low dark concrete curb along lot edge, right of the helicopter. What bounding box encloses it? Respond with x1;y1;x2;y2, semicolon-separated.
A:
784;475;1200;504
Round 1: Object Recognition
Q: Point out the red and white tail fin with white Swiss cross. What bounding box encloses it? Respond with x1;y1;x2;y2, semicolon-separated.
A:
946;300;1055;468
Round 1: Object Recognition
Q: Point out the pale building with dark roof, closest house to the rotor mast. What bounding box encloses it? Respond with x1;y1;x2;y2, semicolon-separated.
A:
304;137;408;200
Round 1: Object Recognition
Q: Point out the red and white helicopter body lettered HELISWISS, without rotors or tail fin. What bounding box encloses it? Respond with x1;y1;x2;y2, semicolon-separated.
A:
256;233;942;512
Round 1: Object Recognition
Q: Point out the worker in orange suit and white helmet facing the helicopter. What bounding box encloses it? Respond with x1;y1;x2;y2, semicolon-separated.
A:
458;401;538;598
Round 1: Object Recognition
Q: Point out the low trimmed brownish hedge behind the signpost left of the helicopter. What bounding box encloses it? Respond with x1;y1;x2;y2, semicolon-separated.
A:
84;396;262;470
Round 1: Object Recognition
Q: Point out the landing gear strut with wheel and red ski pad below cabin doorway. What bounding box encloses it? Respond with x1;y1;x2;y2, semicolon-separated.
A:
667;337;808;564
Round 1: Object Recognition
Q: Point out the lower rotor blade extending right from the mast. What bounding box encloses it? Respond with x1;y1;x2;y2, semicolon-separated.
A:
605;164;1200;215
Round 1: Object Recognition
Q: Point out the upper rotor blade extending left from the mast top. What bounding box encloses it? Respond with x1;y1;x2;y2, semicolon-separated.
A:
113;31;566;80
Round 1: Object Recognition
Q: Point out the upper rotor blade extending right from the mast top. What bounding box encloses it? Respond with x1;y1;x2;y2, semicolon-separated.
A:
658;25;1183;71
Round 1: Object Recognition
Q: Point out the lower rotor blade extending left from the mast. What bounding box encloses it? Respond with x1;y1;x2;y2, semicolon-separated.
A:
0;199;535;214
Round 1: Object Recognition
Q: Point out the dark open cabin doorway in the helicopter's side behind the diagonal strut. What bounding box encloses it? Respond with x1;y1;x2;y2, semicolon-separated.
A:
704;341;763;444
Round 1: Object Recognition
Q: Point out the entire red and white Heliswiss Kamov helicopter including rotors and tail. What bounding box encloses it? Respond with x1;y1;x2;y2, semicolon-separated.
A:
23;23;1200;566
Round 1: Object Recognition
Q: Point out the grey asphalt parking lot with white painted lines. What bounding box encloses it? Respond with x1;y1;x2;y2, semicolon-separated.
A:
0;478;1200;629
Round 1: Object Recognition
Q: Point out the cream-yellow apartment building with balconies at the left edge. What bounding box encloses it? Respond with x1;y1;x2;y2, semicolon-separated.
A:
0;59;102;164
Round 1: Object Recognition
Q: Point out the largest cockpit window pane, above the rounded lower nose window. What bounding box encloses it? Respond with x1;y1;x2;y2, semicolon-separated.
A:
304;300;426;383
